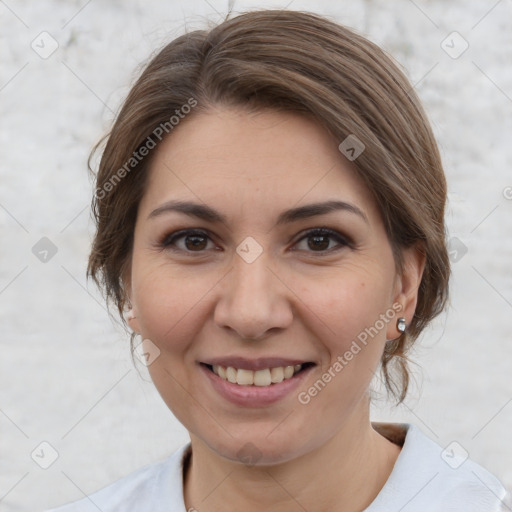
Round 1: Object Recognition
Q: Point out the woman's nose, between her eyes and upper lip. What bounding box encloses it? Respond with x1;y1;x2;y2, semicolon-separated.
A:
214;254;293;340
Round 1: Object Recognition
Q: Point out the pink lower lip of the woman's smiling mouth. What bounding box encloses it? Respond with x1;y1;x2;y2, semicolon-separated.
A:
199;364;313;407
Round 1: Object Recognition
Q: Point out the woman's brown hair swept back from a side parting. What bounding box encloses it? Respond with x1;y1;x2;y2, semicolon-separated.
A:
87;10;450;402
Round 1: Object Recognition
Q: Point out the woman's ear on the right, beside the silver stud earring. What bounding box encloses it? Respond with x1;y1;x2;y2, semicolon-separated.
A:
386;242;425;340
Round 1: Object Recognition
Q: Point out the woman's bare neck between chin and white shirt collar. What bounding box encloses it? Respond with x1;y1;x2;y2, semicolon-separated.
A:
184;406;400;512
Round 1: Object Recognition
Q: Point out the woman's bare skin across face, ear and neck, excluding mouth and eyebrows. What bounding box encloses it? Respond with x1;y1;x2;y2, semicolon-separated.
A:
126;106;424;512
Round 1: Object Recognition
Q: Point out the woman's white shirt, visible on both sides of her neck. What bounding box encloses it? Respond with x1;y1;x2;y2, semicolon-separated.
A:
48;424;512;512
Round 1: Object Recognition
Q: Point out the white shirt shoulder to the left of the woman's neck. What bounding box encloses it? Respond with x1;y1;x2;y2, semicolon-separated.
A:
47;445;190;512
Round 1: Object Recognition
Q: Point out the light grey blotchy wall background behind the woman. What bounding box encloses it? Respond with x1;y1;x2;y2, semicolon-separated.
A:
0;0;512;511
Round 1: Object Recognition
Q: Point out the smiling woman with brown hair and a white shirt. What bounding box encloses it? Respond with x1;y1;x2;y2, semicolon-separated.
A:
48;11;505;512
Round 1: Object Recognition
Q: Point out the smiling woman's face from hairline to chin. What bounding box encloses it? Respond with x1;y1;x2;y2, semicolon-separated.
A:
128;107;418;463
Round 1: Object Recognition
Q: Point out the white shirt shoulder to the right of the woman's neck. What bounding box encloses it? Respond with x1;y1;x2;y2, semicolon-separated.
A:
367;425;506;512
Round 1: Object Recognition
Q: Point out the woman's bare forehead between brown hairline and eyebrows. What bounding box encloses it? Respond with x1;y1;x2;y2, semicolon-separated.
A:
141;107;375;220
